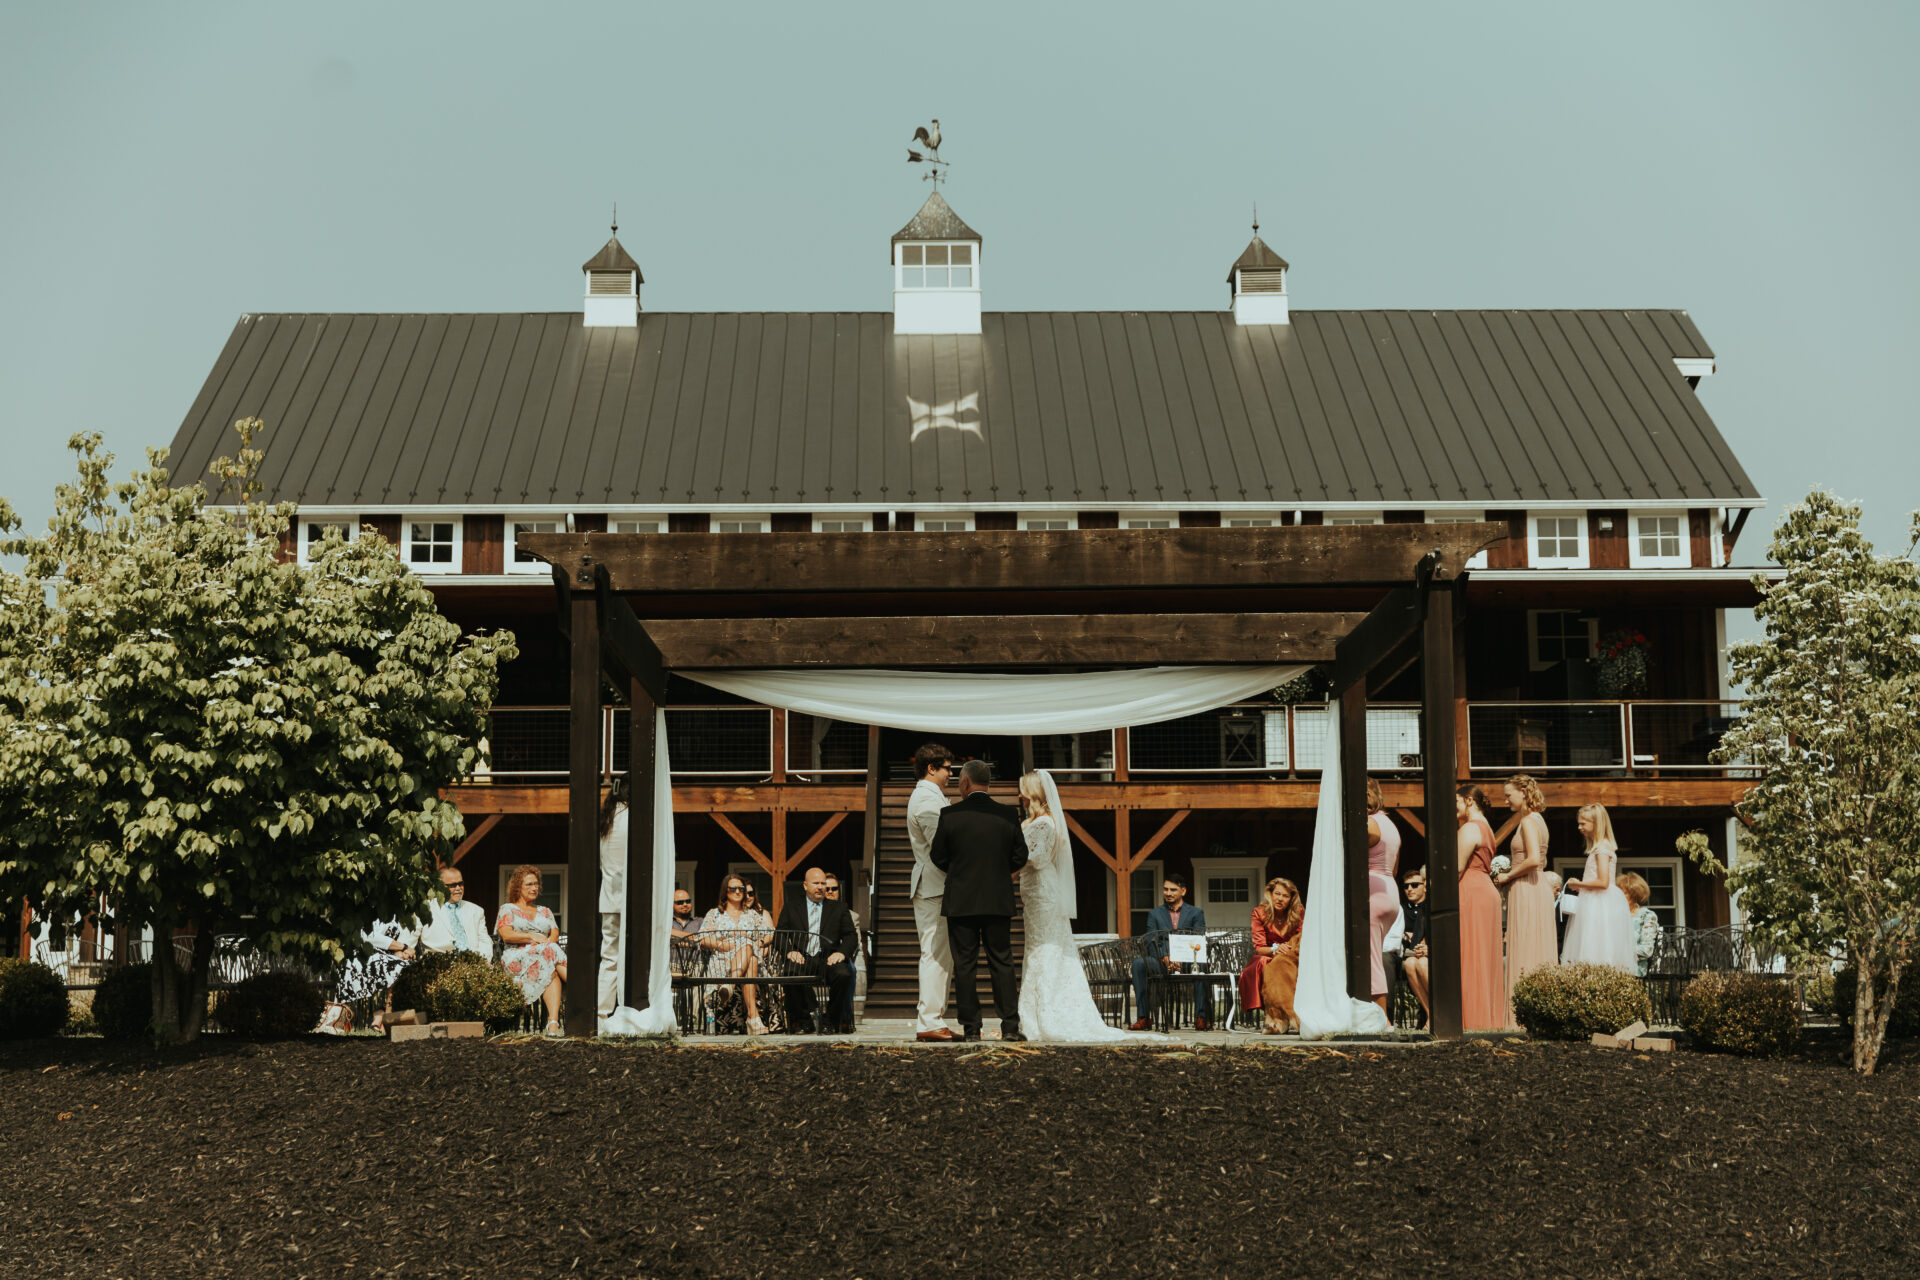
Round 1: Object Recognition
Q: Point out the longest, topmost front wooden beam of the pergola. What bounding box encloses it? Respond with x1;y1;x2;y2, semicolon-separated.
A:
516;520;1509;595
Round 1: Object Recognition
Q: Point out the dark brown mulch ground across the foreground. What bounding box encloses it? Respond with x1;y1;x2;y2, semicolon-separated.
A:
0;1040;1920;1280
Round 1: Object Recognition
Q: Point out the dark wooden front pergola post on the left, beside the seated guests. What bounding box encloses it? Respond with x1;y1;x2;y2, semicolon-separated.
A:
563;591;605;1036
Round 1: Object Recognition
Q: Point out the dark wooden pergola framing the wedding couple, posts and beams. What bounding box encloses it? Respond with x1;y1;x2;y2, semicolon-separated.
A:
518;522;1507;1036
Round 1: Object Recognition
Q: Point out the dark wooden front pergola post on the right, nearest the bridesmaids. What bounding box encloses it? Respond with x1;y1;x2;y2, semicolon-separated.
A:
1421;581;1463;1038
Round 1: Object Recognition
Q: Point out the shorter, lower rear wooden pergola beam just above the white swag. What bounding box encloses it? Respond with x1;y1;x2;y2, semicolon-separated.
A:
637;612;1367;672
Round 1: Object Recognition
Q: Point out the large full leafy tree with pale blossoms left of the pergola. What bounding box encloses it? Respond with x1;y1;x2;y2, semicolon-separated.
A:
0;418;516;1040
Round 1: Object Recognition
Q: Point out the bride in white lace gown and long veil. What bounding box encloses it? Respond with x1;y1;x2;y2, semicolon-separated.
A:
1020;770;1139;1044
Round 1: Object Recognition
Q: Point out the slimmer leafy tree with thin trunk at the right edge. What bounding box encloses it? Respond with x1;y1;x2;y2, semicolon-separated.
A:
1720;491;1920;1075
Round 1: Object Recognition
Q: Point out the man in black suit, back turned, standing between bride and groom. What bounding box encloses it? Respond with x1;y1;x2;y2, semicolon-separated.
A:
931;760;1027;1040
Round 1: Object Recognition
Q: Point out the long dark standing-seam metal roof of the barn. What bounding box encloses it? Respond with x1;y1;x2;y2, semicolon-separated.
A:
173;311;1759;510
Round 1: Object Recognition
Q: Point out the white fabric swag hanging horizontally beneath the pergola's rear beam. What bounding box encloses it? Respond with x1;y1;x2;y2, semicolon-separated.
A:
687;666;1308;735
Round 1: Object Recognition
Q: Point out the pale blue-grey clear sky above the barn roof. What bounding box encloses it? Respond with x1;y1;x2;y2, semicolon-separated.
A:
0;0;1920;562
